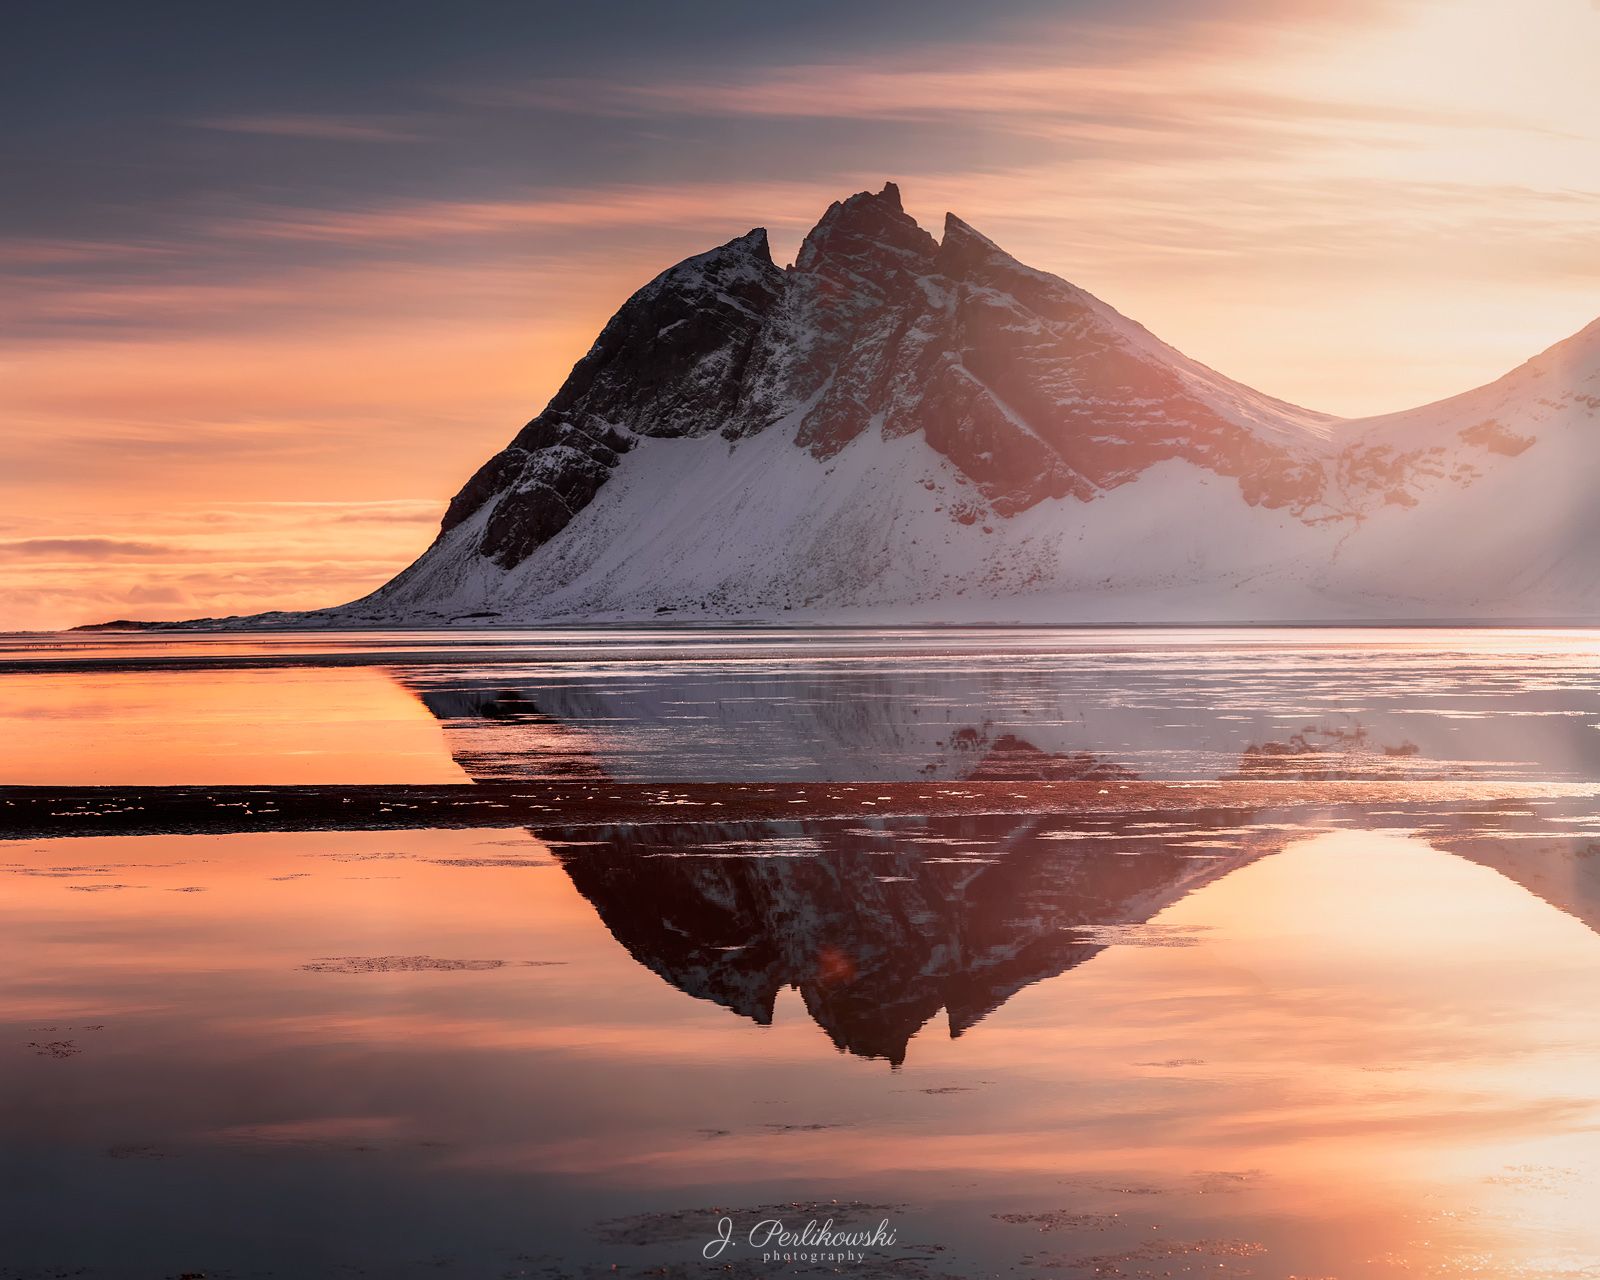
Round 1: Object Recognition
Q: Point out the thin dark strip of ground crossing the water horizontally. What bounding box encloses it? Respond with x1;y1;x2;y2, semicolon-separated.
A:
0;781;1600;838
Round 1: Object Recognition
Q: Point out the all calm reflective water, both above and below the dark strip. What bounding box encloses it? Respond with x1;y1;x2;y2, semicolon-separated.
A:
0;632;1600;1280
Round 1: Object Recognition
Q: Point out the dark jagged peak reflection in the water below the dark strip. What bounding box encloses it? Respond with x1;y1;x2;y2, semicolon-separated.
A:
539;814;1288;1064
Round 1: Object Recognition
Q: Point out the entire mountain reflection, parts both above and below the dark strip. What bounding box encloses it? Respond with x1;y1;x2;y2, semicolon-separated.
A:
368;640;1600;1064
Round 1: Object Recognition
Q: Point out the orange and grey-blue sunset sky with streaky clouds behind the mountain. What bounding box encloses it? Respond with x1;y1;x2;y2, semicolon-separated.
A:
0;0;1600;629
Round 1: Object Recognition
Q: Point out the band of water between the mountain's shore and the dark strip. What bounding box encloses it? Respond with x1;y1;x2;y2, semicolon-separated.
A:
9;629;1600;786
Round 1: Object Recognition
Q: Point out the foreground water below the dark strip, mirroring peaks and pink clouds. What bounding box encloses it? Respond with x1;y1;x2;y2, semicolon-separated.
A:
9;805;1600;1280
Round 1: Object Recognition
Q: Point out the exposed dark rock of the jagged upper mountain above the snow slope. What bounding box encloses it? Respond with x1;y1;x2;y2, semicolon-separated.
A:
425;182;1325;568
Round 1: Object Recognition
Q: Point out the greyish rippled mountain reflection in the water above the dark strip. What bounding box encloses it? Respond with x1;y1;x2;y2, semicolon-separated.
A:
403;634;1600;782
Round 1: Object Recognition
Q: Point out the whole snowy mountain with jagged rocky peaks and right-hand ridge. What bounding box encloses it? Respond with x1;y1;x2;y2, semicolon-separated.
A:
291;182;1600;626
